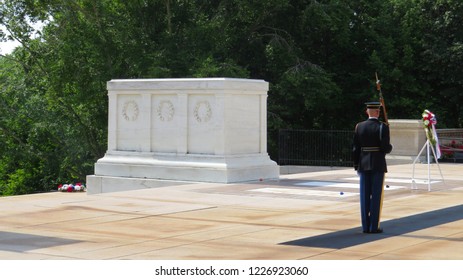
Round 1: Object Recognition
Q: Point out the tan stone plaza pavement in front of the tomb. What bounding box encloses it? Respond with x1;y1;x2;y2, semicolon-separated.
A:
0;163;463;260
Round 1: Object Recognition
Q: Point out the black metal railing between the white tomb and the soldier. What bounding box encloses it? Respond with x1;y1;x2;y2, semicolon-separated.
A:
278;129;353;166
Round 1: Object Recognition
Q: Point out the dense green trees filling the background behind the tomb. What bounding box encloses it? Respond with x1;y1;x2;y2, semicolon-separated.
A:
0;0;463;195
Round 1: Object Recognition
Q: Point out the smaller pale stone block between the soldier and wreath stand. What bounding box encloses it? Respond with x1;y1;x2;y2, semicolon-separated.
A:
387;119;426;164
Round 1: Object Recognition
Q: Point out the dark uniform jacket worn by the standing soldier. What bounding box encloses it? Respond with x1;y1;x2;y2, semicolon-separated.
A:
353;119;392;172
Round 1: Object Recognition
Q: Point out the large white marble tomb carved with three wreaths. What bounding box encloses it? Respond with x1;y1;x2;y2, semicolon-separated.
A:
87;78;279;193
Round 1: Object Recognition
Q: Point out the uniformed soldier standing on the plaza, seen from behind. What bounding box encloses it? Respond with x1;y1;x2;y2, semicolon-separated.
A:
353;102;392;233
